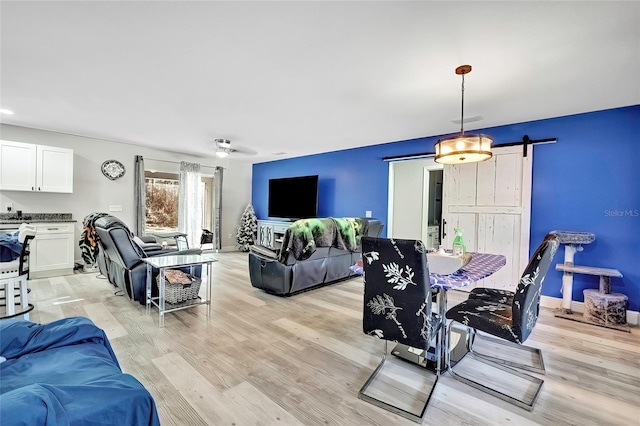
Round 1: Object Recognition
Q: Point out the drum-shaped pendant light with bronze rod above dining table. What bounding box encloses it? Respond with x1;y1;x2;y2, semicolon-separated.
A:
435;65;493;164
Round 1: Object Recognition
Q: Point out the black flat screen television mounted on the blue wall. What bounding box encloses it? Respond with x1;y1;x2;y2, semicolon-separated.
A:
268;175;318;219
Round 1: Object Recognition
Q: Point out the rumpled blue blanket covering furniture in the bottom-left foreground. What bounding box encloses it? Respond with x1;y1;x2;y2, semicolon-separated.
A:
0;317;160;426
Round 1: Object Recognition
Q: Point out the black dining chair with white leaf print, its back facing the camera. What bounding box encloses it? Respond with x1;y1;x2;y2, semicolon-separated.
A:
358;237;444;422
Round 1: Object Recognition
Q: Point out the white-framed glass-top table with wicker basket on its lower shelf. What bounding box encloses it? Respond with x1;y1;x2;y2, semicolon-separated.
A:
142;253;218;327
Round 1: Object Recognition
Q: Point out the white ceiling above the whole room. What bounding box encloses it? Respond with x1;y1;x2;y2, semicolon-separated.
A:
0;1;640;162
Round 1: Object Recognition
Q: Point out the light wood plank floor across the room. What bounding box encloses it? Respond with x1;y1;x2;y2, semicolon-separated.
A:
23;253;640;426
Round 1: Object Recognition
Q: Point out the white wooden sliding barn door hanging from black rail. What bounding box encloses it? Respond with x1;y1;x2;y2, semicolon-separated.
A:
442;145;533;291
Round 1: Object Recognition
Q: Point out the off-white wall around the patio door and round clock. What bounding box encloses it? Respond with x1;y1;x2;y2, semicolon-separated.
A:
0;124;252;260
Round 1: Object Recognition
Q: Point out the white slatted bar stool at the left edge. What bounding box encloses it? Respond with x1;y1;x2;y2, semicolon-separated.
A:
0;223;36;320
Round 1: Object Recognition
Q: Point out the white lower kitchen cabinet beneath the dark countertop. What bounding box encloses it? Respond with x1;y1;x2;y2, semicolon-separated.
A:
29;222;75;278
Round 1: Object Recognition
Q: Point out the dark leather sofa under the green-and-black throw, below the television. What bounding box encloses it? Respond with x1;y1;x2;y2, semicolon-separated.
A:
249;218;383;296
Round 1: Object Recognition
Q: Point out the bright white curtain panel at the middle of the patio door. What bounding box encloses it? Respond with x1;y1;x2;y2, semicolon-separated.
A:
178;161;202;248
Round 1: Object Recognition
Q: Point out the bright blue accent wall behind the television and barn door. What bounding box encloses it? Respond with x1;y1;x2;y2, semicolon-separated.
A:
252;105;640;311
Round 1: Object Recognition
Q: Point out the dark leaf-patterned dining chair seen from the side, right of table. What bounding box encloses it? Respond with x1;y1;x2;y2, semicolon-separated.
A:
446;234;560;410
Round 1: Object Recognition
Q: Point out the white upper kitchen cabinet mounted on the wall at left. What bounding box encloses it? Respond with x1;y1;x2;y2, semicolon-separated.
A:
0;141;73;193
